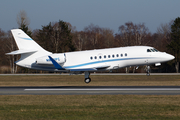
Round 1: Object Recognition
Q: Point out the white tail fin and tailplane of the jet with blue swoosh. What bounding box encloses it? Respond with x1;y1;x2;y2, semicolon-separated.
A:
6;29;52;66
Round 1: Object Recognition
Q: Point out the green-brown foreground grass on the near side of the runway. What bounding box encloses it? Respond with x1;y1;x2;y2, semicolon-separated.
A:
0;95;180;120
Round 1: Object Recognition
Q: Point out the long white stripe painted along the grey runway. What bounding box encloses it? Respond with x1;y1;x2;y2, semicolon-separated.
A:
24;88;180;91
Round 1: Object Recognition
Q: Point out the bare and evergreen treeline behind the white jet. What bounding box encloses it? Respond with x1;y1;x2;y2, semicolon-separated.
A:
0;11;180;73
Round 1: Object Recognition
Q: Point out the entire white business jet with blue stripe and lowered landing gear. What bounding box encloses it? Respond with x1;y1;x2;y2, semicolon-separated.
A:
7;29;174;83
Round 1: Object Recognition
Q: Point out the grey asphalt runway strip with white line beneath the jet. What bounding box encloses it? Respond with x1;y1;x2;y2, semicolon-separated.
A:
0;86;180;95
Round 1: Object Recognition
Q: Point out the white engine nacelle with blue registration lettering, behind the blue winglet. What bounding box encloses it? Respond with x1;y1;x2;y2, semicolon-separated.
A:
36;53;66;65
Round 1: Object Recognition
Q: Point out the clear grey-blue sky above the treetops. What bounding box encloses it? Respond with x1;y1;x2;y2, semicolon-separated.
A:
0;0;180;33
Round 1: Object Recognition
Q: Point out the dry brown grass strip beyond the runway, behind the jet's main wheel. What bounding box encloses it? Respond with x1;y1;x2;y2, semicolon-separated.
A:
0;75;180;86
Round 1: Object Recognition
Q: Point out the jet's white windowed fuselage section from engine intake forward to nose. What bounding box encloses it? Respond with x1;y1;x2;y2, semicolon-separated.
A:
64;46;173;69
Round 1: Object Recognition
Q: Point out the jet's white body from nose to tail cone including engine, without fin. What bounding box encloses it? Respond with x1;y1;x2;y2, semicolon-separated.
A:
16;46;174;71
